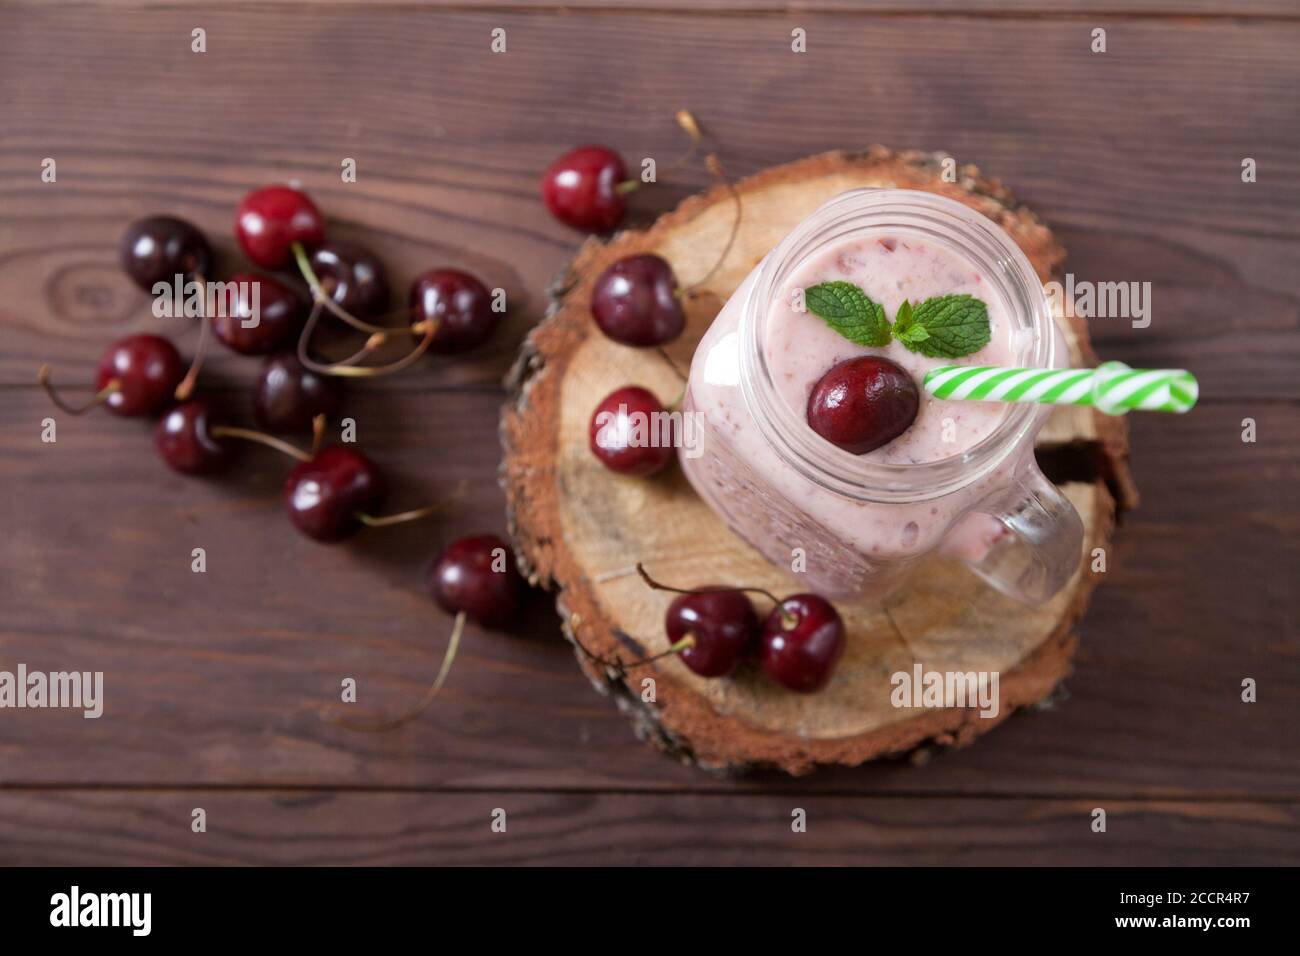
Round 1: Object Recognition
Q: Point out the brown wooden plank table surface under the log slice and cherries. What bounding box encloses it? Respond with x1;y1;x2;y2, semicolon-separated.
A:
0;0;1300;864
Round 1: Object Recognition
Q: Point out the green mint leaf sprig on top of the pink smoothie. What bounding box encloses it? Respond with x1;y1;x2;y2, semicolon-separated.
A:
803;281;989;359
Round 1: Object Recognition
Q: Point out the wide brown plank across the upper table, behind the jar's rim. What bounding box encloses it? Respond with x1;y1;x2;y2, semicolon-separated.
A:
0;5;1300;398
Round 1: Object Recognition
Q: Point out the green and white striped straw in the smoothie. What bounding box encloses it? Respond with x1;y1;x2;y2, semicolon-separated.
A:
924;362;1199;415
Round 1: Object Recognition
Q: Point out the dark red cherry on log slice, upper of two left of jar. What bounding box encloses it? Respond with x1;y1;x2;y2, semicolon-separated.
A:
592;252;686;346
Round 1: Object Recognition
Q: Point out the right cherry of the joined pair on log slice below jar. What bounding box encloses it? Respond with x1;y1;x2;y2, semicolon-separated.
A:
759;594;844;693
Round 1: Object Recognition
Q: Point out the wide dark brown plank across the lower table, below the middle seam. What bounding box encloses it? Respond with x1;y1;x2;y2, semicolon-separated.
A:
0;388;1300;799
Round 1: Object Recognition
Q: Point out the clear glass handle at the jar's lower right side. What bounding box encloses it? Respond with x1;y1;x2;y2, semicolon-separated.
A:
965;455;1083;604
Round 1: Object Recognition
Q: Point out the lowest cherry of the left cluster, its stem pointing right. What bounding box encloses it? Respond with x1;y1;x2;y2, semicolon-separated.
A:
285;445;384;542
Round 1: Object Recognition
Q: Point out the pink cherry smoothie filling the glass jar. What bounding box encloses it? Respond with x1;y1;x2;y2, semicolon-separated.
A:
680;230;1055;596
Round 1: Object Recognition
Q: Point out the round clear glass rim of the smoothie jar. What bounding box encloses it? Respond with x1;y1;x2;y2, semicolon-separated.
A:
740;189;1056;502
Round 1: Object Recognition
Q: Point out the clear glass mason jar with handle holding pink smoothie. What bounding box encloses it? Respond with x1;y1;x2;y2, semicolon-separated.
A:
679;189;1083;604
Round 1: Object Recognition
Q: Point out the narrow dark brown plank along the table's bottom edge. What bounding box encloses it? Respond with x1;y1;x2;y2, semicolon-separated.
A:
0;791;1300;866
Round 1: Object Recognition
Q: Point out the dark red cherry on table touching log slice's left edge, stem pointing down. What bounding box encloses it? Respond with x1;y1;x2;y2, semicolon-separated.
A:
428;535;523;627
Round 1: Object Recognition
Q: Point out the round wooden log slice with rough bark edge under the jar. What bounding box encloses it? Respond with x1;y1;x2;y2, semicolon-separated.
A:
501;147;1136;774
